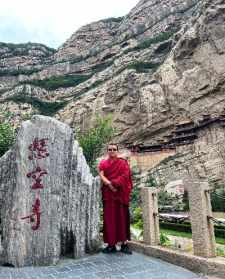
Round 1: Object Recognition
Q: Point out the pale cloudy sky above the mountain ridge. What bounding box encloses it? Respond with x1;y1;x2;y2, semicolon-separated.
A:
0;0;139;48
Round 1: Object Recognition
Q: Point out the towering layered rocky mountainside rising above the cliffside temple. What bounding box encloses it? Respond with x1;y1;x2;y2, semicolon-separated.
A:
0;0;225;149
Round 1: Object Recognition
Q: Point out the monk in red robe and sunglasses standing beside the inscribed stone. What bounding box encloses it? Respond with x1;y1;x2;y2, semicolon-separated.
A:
99;144;132;254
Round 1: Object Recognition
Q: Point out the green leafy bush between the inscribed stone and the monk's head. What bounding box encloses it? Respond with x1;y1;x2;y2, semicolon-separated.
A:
78;116;115;174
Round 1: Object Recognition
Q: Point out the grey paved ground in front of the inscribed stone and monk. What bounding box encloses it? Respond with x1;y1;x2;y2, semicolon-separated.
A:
0;252;205;279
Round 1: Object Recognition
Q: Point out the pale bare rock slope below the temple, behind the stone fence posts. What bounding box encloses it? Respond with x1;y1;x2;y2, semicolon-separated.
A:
150;123;225;186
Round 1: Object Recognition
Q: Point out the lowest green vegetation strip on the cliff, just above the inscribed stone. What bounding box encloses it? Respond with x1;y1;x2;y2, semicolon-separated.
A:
4;95;68;116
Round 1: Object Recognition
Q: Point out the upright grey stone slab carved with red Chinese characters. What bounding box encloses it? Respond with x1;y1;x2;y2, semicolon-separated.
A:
0;115;99;266
